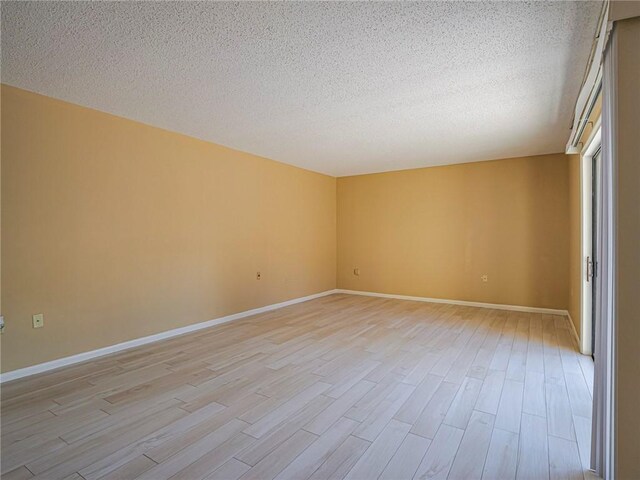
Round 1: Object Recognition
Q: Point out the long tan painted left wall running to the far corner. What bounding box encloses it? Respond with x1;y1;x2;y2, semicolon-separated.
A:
1;86;336;371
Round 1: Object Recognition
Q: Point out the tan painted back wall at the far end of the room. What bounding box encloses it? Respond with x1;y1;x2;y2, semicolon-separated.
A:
337;154;569;309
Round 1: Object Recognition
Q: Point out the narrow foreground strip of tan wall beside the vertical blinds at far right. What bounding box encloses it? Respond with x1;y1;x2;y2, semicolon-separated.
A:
615;17;640;480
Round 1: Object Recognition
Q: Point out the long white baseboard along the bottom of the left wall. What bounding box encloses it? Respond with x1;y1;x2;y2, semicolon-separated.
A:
0;290;336;383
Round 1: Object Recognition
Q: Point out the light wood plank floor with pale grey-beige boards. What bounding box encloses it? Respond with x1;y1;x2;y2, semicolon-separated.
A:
1;295;593;480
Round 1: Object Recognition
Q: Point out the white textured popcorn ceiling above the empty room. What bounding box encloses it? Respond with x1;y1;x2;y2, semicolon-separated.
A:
1;1;600;176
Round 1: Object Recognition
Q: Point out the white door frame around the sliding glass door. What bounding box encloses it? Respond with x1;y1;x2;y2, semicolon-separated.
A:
580;118;602;355
